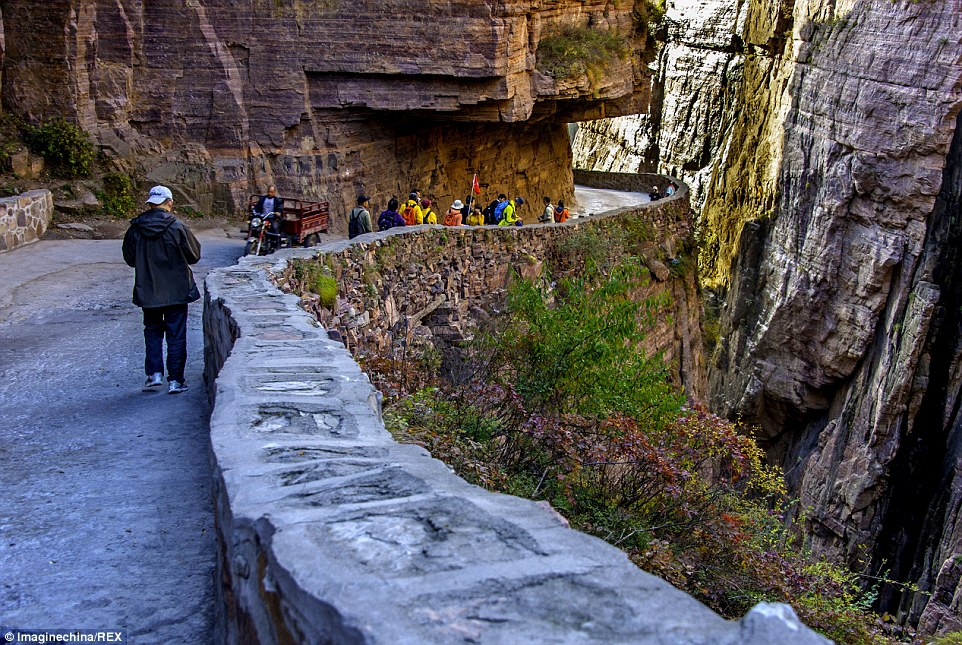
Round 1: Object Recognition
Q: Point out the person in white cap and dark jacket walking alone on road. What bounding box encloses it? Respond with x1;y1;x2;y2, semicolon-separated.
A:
123;186;200;394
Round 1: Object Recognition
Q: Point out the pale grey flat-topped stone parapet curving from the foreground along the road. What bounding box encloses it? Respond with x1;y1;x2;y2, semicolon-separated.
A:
204;174;827;645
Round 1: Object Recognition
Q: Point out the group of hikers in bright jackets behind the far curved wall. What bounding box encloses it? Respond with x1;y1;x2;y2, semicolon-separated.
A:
348;188;569;238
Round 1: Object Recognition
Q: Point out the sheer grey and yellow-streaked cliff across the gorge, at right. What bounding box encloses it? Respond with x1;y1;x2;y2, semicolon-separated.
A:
575;0;962;631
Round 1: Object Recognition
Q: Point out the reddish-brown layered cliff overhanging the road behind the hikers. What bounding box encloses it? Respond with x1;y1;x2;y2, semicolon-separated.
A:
0;0;649;226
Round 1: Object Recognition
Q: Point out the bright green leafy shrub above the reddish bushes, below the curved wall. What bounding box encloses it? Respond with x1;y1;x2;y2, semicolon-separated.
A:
481;258;684;427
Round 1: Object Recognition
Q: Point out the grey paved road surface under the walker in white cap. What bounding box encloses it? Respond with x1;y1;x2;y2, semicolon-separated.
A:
0;230;243;644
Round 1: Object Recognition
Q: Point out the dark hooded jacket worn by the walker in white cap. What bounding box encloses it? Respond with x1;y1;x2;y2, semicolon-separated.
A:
123;208;200;309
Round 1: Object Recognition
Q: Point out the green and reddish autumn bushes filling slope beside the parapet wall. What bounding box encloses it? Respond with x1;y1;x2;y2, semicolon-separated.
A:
363;257;886;643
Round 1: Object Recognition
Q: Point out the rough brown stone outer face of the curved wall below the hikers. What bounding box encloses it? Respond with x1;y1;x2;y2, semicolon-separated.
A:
282;184;706;399
